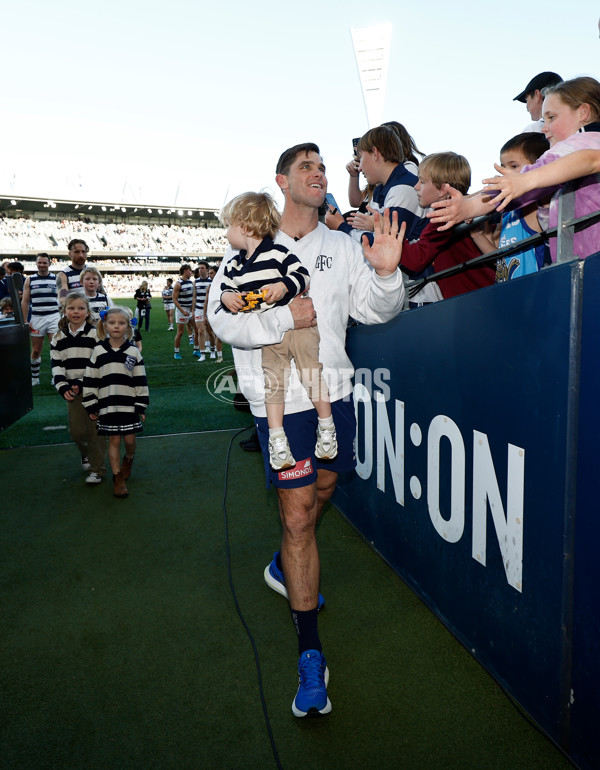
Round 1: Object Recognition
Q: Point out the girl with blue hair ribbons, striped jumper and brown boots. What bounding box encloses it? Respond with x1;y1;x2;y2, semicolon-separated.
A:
83;306;149;497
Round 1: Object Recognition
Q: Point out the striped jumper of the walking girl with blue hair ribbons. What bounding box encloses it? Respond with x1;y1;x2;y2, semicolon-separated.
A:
82;339;149;417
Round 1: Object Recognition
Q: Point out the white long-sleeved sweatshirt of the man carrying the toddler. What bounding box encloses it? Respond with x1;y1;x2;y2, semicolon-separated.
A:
208;223;404;417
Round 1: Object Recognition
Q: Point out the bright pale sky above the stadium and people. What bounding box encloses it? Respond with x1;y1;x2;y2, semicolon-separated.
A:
0;0;600;213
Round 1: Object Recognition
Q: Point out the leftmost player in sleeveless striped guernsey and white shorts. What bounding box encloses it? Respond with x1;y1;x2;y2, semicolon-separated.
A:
21;253;60;385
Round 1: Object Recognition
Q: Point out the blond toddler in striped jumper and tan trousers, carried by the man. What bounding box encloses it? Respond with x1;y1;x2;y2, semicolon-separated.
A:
221;192;337;471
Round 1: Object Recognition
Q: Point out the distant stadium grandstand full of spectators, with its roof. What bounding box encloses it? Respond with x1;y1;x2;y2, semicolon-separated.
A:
0;195;227;296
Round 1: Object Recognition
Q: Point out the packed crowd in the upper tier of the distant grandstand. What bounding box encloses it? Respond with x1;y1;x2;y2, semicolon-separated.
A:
0;215;227;257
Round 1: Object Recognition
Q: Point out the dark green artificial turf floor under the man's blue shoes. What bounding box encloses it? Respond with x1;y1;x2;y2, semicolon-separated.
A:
0;431;569;770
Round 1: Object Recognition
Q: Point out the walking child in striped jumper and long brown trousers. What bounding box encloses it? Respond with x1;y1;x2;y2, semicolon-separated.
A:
50;291;106;486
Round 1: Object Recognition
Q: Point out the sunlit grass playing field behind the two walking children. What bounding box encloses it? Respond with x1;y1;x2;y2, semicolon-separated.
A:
0;299;252;449
